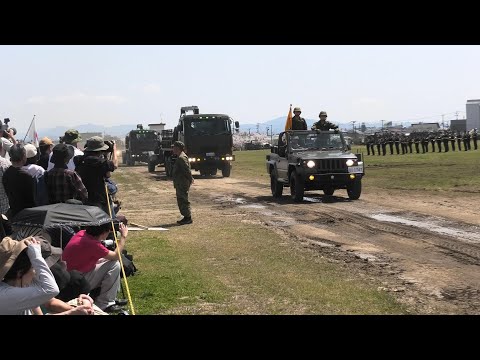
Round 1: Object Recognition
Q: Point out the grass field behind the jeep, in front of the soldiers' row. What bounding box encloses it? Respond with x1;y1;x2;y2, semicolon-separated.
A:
232;146;480;192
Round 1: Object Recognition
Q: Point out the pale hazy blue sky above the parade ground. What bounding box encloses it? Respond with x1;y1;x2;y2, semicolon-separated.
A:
0;45;480;136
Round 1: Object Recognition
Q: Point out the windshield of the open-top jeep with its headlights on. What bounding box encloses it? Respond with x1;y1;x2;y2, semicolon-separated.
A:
289;132;344;151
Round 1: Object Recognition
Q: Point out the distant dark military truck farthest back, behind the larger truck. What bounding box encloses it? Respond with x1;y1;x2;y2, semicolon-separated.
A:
122;124;161;166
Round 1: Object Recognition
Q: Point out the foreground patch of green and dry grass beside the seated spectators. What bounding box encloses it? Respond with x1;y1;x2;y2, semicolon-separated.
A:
127;221;405;314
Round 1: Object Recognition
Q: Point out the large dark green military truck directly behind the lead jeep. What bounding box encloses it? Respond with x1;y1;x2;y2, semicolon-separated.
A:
173;106;239;177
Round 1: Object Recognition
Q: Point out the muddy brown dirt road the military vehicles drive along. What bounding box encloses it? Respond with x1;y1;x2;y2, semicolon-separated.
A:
121;166;480;314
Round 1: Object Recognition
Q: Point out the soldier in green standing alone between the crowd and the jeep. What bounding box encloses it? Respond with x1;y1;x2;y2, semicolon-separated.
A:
172;141;194;225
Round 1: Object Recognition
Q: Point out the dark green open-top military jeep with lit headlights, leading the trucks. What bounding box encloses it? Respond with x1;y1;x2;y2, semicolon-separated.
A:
266;130;365;202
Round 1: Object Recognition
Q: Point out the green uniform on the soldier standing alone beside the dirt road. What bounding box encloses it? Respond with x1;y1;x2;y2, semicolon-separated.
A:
172;151;193;219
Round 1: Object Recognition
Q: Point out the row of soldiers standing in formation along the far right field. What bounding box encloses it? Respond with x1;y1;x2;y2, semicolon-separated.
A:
365;129;478;155
